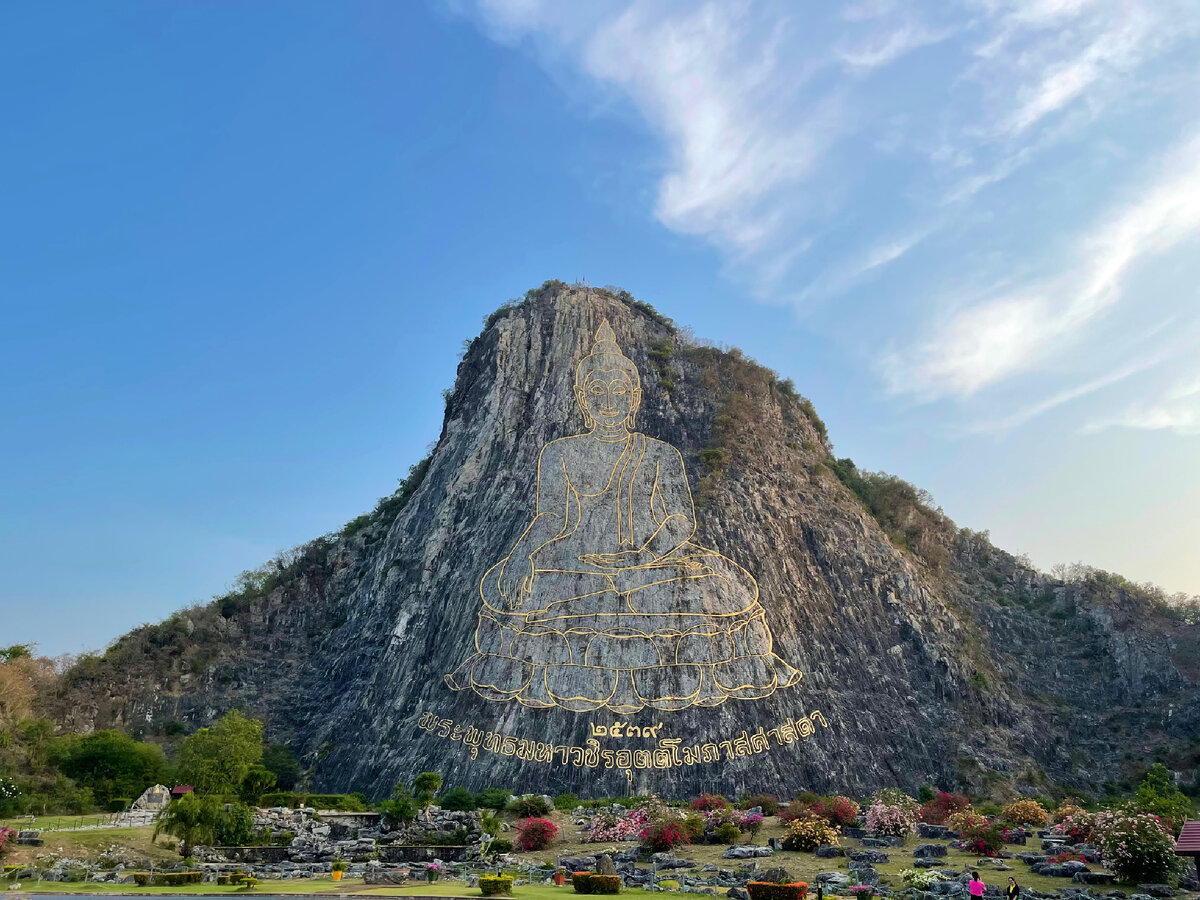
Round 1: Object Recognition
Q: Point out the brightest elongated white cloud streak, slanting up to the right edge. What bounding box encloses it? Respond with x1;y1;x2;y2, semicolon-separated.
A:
883;137;1200;400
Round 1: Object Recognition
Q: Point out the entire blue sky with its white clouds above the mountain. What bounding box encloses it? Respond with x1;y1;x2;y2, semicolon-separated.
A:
0;0;1200;654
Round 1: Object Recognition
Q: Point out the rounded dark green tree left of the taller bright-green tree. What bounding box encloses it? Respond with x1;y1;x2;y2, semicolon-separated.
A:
52;731;167;804
